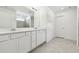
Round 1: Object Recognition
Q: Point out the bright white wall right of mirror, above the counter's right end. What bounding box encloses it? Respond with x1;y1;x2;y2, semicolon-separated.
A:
34;6;47;27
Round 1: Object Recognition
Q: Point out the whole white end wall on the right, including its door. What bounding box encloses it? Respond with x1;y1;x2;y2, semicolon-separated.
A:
56;9;77;40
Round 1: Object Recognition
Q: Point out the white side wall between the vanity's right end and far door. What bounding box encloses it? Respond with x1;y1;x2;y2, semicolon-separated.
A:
47;8;56;42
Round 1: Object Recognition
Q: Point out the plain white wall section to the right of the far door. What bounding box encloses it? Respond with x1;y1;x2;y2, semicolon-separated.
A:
64;9;77;40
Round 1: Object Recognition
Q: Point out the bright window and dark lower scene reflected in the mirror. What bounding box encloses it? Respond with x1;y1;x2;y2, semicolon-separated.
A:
16;12;34;28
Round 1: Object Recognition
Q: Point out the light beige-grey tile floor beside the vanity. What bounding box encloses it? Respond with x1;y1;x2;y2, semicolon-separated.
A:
32;38;79;53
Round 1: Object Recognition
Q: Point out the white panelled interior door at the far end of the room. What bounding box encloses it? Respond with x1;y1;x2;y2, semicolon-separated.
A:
56;16;64;38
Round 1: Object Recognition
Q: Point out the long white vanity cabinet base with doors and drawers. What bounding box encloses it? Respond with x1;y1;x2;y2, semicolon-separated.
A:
0;29;46;53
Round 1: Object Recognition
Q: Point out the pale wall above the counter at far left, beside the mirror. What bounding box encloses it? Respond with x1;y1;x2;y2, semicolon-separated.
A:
0;7;16;28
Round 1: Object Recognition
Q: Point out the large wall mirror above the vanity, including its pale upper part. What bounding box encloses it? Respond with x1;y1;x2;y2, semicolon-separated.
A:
16;7;34;28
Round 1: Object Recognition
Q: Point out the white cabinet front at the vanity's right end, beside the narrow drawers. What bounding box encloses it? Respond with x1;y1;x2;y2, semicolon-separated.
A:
37;30;45;46
